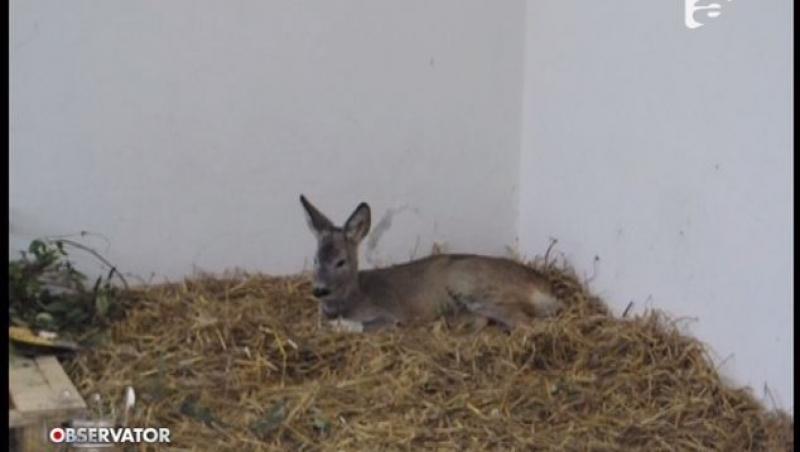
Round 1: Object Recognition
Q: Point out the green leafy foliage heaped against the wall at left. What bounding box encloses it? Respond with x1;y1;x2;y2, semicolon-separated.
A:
8;240;122;338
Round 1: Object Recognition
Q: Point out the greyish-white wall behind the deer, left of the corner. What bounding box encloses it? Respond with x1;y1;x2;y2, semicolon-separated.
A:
10;0;524;278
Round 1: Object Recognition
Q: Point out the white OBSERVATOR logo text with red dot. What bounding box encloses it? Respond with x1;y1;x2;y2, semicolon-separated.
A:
49;427;170;447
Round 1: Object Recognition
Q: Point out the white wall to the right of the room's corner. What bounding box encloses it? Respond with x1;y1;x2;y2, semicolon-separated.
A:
519;0;793;409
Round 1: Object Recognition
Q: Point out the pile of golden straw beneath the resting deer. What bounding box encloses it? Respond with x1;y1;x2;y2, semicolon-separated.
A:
66;266;794;451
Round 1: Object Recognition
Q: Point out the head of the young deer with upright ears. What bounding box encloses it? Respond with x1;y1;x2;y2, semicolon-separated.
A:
300;195;370;317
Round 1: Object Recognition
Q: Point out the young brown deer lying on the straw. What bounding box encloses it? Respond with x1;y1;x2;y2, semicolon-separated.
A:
300;195;563;331
